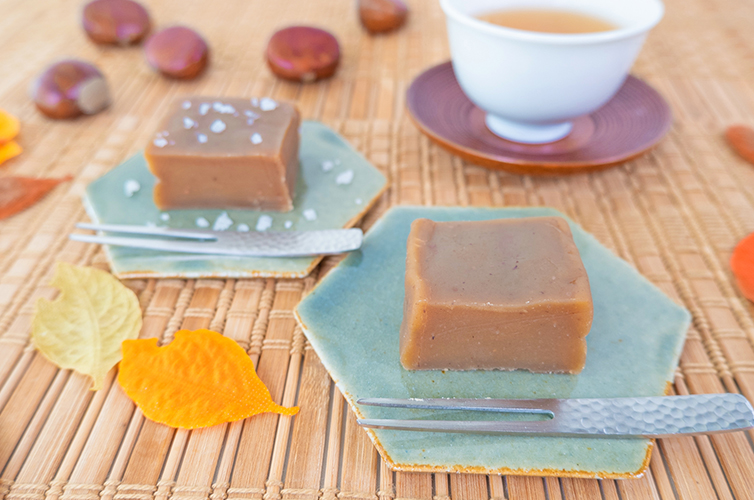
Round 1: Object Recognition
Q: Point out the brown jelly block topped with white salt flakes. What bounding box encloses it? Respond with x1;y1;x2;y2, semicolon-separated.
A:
144;97;300;212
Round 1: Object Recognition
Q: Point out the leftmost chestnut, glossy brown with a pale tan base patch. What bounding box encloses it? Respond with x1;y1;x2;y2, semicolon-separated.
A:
31;59;110;119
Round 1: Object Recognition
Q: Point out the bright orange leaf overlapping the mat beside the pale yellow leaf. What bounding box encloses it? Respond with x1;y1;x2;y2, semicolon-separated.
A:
118;330;298;429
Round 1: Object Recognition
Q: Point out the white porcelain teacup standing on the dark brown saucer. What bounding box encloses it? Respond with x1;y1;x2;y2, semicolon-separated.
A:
440;0;664;144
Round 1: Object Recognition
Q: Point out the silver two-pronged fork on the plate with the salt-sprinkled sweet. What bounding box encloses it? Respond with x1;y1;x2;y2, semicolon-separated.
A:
69;222;364;257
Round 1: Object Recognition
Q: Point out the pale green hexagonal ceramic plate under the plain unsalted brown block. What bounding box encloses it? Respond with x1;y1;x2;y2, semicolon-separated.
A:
297;207;690;478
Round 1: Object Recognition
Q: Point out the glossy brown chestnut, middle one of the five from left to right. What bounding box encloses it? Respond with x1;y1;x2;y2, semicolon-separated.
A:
144;26;209;80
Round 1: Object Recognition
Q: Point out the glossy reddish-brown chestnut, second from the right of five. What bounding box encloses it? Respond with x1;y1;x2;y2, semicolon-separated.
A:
266;26;340;82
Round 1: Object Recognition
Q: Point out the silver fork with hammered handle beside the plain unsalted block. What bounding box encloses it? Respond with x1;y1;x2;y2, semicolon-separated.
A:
356;394;754;438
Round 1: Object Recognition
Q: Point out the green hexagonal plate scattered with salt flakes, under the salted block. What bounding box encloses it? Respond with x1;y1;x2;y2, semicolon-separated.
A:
84;122;387;278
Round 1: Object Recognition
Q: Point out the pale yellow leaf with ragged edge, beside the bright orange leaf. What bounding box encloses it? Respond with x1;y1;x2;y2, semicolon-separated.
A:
32;262;141;391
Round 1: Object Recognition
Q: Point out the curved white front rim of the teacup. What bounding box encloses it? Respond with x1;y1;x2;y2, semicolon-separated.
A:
439;0;665;45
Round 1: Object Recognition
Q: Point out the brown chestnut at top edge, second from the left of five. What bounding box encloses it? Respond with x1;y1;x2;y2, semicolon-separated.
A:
82;0;152;45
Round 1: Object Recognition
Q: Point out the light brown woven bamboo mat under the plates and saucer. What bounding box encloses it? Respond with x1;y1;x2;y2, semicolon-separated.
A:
0;0;754;500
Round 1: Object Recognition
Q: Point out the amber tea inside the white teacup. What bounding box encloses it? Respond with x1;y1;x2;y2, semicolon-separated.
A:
477;9;618;34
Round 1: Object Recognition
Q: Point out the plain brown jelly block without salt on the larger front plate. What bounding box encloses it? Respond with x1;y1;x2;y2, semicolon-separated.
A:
400;217;592;373
